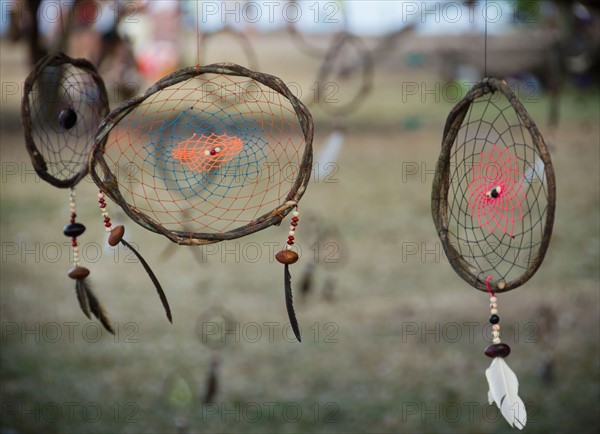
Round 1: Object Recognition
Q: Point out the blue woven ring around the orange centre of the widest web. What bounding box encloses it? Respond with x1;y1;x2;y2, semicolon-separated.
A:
144;107;269;200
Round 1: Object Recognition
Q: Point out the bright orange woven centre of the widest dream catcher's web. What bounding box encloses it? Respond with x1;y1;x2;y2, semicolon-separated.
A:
172;133;244;172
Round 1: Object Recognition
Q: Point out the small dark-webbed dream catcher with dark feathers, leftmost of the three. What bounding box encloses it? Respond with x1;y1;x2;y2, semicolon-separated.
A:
21;53;113;333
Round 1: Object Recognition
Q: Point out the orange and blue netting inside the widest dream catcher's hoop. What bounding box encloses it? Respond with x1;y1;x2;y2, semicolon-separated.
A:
97;73;305;234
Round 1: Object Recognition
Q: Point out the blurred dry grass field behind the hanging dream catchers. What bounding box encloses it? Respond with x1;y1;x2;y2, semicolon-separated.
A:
0;2;600;434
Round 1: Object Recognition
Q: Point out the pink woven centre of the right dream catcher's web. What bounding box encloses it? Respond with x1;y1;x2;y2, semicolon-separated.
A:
467;145;526;238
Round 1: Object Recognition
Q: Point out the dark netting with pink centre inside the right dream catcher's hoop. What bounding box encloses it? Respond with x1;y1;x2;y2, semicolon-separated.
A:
448;87;550;281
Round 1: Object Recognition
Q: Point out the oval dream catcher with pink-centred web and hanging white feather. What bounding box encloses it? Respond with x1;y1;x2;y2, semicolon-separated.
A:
431;78;556;429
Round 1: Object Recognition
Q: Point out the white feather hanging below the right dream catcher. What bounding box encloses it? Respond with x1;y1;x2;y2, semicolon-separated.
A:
485;357;527;429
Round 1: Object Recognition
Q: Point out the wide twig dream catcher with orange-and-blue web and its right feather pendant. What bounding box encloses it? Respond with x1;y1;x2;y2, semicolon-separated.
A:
90;63;313;340
